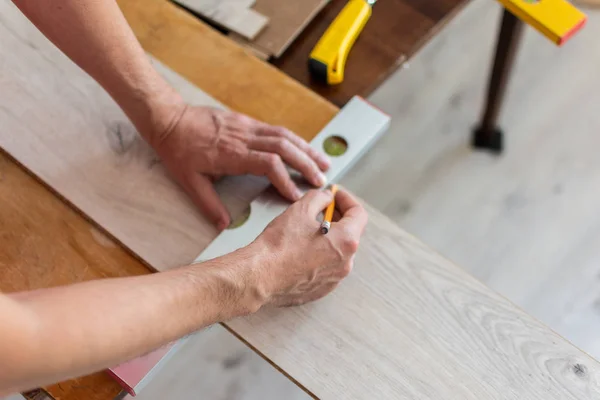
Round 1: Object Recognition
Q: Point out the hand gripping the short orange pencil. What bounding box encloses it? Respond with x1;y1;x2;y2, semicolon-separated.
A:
251;189;368;307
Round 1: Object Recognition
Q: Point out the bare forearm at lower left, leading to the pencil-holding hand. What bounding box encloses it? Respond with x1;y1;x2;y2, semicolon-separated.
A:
0;245;264;395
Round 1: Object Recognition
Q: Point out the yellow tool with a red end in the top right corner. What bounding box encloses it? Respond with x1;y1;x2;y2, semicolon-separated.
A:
499;0;587;46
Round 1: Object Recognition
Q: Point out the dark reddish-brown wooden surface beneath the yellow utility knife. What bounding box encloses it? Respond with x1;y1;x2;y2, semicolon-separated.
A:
274;0;467;106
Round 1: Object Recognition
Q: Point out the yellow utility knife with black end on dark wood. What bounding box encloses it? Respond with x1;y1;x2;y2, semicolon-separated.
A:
308;0;375;85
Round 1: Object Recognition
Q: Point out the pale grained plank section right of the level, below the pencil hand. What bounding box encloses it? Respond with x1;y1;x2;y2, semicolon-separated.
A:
134;206;600;400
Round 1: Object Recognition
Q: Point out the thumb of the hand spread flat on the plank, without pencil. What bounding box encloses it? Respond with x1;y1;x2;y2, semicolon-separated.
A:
185;173;231;231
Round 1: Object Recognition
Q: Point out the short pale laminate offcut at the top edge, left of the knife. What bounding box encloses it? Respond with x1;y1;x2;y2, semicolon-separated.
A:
176;0;269;40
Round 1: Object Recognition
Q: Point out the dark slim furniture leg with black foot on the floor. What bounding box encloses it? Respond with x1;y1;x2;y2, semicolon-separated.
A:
472;9;523;154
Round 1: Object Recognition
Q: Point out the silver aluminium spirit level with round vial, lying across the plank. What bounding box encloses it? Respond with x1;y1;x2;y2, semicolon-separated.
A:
118;96;390;398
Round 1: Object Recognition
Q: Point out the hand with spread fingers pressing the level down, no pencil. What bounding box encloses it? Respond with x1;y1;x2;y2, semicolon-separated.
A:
151;106;329;230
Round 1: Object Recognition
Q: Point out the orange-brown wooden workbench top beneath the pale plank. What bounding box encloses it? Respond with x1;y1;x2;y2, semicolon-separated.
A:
0;0;597;399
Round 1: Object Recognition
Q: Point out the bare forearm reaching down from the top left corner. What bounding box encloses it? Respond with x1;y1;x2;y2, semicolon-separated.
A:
13;0;184;141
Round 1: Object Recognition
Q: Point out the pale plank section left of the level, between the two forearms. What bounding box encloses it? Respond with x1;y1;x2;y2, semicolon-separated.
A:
0;1;248;270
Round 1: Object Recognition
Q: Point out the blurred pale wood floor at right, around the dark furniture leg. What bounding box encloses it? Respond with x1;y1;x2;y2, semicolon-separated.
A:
342;0;600;378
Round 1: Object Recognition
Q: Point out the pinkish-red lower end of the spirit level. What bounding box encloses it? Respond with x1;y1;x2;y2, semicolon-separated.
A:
107;343;175;396
